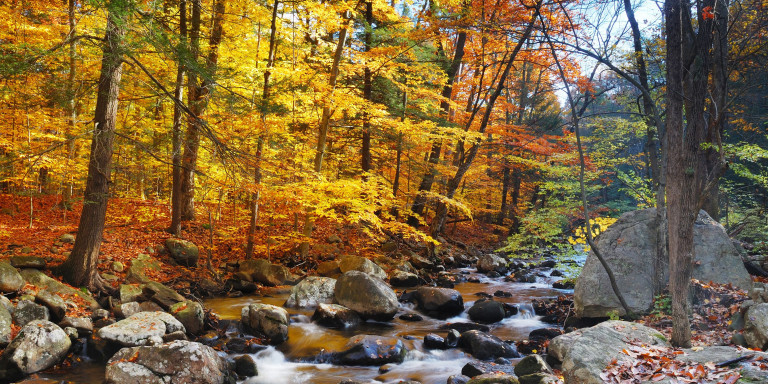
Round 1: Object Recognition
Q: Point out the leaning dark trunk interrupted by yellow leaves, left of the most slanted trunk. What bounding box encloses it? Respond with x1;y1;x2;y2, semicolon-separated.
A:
408;31;467;227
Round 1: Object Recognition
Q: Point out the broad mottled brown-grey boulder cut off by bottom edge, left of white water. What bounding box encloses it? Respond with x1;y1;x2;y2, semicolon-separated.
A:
106;340;232;384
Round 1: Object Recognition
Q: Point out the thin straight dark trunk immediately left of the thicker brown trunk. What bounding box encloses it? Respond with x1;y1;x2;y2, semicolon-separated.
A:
168;0;187;236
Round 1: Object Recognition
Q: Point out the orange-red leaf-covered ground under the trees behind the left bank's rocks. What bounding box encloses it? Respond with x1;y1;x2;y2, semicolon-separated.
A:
0;194;500;292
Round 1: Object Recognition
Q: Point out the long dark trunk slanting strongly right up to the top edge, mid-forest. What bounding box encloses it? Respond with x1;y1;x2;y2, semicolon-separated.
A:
431;6;541;238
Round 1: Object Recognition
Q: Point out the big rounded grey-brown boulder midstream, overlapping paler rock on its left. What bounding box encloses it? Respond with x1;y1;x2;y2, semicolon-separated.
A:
333;271;399;321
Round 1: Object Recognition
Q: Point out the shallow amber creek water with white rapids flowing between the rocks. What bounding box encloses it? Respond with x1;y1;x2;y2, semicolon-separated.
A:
40;269;566;384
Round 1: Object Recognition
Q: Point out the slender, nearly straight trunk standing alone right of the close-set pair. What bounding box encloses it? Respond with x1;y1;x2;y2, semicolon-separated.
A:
245;0;280;259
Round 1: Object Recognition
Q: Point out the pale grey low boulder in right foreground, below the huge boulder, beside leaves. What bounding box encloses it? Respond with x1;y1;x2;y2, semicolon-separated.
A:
547;321;669;384
